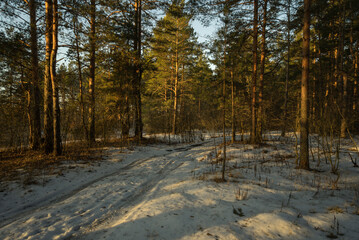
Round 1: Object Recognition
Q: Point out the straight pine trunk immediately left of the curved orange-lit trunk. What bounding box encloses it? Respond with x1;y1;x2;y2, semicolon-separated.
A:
44;0;54;154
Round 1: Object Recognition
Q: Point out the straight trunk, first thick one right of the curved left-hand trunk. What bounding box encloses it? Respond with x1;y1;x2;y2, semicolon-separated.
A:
89;0;96;144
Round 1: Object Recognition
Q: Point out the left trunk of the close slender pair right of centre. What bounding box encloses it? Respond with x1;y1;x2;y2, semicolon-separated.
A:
251;0;258;144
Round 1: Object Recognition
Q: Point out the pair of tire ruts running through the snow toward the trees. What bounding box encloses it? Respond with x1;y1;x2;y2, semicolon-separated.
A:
0;142;210;238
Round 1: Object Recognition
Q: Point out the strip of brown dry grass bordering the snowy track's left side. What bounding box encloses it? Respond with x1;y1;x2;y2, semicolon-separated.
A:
0;138;158;185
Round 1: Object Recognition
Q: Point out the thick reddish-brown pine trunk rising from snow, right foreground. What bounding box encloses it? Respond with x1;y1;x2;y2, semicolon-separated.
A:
299;0;311;169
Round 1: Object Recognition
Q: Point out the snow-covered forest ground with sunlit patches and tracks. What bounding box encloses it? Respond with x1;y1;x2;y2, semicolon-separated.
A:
0;133;359;240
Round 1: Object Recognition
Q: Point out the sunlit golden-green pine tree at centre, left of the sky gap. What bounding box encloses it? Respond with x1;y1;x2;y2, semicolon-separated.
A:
152;1;198;134
